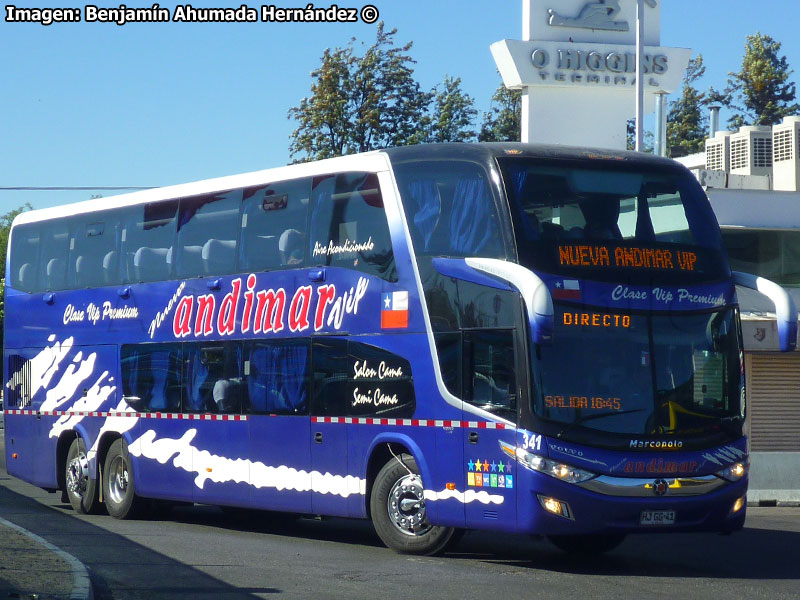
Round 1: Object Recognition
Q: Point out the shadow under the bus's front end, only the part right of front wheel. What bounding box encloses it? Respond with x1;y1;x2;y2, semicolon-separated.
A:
449;527;800;580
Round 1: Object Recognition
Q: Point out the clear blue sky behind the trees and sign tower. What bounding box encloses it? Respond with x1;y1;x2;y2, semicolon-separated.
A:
0;0;800;214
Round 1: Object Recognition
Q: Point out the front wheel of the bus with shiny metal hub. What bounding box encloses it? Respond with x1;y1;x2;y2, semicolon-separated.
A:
370;454;455;556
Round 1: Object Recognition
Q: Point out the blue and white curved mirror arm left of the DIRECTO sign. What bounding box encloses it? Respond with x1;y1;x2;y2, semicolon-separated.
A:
433;258;554;345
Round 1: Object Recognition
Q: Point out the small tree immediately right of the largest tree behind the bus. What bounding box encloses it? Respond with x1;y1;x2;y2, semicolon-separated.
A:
426;76;478;143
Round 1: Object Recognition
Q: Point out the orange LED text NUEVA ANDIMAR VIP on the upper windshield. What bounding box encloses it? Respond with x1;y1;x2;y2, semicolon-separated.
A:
558;244;698;273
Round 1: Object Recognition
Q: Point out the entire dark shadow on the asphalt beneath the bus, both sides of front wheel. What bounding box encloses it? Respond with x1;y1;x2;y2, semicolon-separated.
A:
161;505;800;580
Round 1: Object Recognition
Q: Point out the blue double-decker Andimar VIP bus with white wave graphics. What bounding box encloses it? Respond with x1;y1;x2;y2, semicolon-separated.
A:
3;144;797;554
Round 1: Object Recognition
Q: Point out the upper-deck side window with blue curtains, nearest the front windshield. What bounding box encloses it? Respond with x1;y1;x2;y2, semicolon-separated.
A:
395;161;506;258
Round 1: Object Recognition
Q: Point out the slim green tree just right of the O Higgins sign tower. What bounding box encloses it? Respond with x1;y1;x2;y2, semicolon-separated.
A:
667;54;708;156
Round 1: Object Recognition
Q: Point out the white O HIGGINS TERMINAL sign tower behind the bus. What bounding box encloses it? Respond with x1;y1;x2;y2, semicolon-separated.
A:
492;0;691;150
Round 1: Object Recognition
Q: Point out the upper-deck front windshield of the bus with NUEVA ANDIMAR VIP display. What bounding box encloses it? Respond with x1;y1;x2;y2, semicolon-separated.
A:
498;157;730;283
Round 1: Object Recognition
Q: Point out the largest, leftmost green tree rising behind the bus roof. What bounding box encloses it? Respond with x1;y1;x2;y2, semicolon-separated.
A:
289;22;431;161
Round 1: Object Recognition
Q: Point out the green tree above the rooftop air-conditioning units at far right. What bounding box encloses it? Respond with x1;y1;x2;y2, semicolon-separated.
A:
724;32;800;128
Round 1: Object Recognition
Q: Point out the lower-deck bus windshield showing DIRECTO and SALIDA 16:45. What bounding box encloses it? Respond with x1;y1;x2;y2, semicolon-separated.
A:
532;303;744;438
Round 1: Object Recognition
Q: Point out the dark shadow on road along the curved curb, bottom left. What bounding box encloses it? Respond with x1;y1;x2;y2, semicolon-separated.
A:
0;486;282;600
